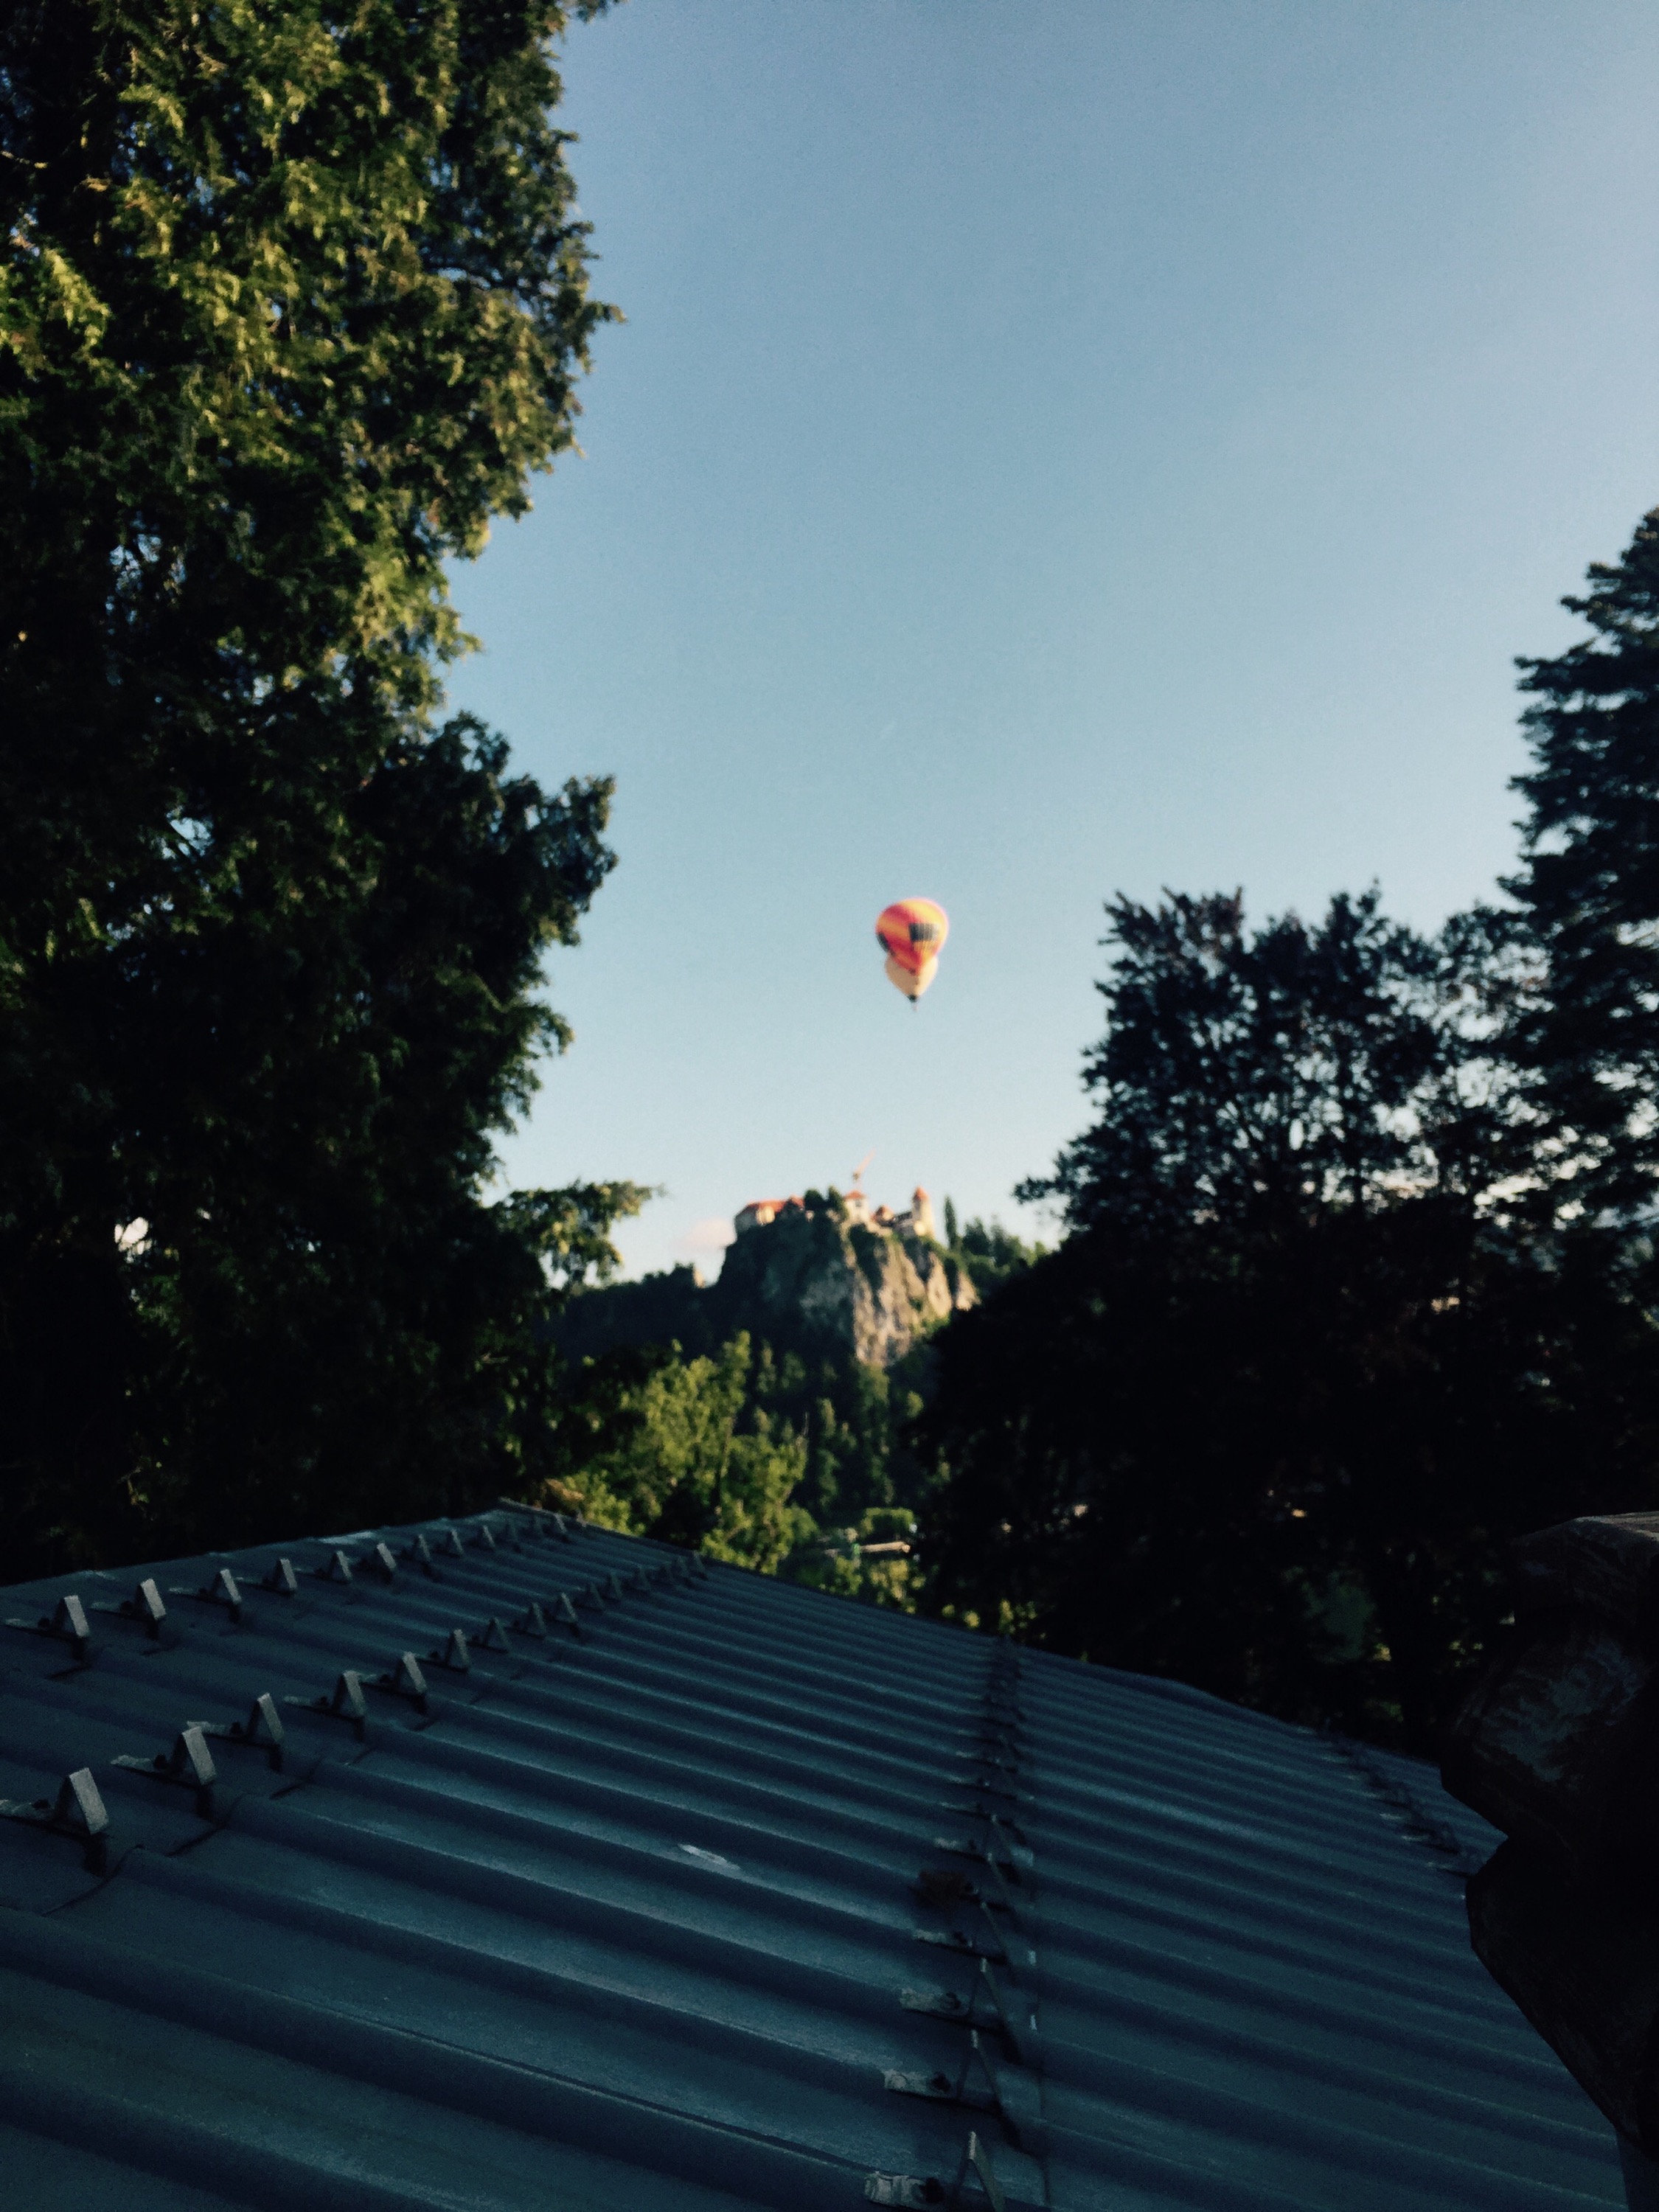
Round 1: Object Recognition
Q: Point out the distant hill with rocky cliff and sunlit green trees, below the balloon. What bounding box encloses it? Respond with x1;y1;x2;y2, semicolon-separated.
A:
546;1190;1031;1606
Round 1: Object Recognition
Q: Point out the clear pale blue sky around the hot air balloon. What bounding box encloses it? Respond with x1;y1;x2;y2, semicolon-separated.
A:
451;0;1659;1270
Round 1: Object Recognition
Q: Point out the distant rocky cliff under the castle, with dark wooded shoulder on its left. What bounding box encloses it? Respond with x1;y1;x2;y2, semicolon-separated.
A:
557;1212;978;1367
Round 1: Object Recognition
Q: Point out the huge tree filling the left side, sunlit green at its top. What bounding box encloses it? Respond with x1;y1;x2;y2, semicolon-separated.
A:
0;0;639;1573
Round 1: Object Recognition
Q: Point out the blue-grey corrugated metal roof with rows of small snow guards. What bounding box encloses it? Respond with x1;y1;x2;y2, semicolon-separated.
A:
0;1513;1621;2212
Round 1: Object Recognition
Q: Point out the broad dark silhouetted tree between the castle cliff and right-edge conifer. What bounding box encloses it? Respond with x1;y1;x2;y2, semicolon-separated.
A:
920;876;1659;1750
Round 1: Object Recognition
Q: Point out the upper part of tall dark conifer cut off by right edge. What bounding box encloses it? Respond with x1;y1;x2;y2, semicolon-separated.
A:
1509;509;1659;1223
